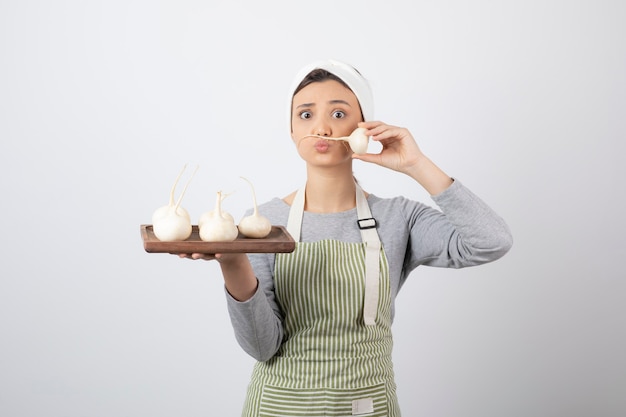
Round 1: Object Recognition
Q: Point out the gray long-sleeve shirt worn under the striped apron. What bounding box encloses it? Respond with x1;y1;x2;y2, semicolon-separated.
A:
226;180;513;361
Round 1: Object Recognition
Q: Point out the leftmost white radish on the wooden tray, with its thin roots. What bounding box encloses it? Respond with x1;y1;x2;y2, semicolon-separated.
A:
152;164;198;242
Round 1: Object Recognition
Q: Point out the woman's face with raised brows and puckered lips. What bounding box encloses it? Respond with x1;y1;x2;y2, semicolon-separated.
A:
291;80;363;161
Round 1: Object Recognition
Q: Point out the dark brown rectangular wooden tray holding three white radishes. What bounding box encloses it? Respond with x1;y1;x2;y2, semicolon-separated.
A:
141;224;296;254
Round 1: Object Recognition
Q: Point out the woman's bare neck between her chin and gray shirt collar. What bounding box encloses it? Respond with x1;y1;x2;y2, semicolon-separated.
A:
304;166;356;213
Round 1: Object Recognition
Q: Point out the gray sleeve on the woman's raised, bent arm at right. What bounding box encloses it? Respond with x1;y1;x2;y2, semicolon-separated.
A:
408;180;513;269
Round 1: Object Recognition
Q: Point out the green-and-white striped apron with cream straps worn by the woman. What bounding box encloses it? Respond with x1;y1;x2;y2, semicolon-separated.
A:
242;185;400;417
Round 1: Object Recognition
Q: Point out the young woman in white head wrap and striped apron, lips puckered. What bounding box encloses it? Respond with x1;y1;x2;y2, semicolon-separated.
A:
181;61;512;417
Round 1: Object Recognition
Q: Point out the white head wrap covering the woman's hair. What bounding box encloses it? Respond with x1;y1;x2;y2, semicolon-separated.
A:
288;59;374;132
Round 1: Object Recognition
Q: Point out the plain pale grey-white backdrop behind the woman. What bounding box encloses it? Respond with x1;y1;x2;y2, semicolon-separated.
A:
0;0;626;417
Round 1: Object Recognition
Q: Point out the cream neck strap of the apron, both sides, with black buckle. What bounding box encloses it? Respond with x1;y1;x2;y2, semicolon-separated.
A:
287;184;381;326
